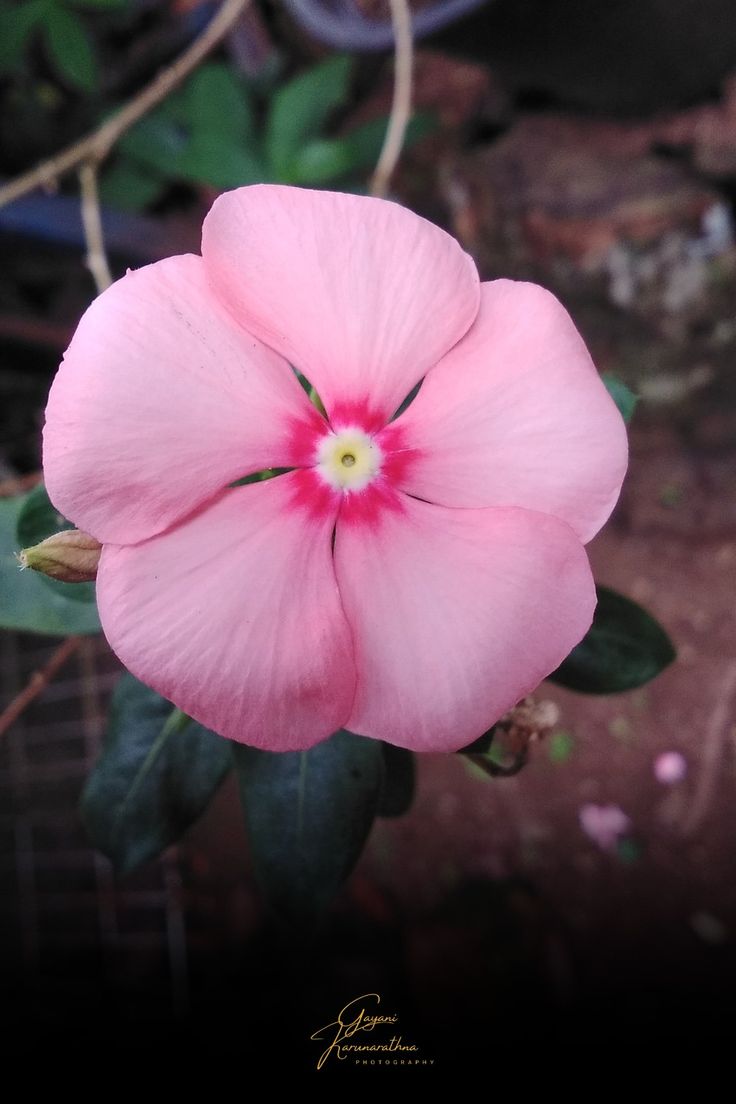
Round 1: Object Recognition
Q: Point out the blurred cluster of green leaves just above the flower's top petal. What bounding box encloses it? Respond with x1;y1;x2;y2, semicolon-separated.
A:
102;55;431;210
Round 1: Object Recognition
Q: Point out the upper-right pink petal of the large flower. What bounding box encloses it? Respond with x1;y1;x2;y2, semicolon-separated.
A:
388;279;627;541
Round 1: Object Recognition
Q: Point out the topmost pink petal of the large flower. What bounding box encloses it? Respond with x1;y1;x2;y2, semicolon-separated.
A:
202;184;479;428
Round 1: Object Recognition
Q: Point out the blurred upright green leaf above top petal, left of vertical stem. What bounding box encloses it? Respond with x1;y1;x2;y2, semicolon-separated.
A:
265;54;352;180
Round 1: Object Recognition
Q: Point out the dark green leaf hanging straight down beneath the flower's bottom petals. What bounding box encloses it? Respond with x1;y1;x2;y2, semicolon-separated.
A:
233;730;384;925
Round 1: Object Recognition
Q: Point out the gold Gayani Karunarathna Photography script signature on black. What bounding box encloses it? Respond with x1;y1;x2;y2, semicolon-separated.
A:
310;992;435;1070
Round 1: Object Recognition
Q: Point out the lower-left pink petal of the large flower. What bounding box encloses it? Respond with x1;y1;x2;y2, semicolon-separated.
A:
97;473;355;751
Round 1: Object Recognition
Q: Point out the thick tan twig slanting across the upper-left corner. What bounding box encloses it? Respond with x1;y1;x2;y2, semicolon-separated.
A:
0;0;250;206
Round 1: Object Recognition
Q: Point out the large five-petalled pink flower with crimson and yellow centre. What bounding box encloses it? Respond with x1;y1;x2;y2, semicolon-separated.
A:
44;185;627;751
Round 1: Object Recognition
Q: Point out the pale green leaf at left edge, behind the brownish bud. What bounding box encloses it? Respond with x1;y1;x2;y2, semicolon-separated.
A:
0;492;99;636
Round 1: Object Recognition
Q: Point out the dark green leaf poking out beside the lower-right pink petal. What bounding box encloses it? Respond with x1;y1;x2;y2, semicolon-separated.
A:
550;586;675;693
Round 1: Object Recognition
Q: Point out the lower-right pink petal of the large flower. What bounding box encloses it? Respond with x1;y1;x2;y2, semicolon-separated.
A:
335;495;596;752
